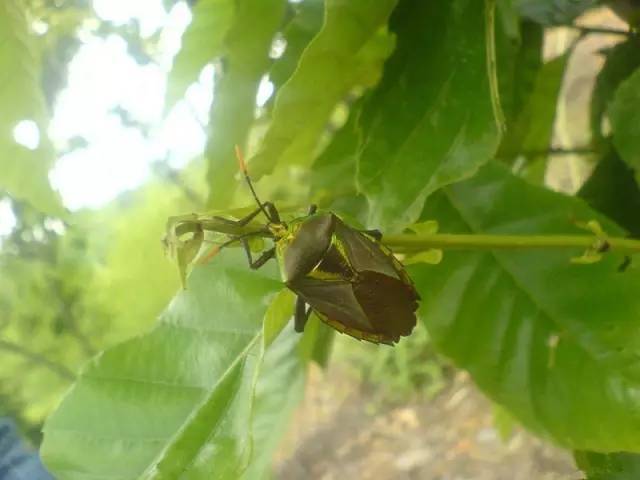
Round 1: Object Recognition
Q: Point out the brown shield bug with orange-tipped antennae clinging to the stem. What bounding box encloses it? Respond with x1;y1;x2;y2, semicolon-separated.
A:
169;149;420;345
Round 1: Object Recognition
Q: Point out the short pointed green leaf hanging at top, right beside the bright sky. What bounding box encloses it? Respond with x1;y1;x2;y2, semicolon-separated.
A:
164;0;236;110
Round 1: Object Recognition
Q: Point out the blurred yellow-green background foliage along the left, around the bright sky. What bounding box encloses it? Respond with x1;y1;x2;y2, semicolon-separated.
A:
0;0;205;442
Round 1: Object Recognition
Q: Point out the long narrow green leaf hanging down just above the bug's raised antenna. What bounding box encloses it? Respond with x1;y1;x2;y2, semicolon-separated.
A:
206;0;286;208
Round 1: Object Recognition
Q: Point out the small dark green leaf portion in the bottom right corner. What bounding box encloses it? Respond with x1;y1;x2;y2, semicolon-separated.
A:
574;452;640;480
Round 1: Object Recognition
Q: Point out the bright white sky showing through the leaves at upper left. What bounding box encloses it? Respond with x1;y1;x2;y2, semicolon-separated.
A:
0;0;273;236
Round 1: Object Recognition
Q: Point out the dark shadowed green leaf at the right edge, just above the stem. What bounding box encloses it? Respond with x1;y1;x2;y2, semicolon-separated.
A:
578;151;640;237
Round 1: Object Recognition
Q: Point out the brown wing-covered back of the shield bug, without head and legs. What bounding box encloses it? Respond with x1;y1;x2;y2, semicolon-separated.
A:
287;214;420;344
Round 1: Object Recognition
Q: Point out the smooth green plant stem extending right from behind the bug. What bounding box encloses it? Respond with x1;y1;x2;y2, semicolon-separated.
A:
382;233;640;253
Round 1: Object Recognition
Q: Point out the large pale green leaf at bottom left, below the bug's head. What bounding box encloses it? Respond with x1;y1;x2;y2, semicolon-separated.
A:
42;250;301;479
